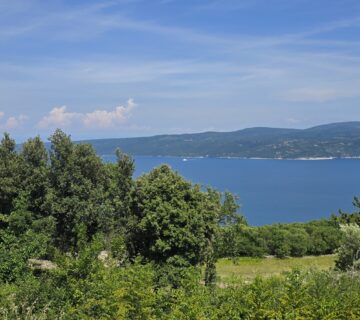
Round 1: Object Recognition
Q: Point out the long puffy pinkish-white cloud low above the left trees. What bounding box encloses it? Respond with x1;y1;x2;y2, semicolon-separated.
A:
37;98;136;129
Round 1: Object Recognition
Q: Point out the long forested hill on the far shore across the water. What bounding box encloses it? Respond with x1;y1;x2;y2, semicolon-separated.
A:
82;121;360;159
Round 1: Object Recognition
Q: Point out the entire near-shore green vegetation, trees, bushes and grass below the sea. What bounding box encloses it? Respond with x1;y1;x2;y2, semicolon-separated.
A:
0;130;360;320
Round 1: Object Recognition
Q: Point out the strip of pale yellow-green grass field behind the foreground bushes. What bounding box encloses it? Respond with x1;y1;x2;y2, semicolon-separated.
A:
216;255;336;282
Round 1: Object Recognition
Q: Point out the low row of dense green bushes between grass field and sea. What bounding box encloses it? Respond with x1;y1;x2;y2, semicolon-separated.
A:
216;219;341;258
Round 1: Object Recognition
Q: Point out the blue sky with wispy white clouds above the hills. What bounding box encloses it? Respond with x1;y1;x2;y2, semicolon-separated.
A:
0;0;360;141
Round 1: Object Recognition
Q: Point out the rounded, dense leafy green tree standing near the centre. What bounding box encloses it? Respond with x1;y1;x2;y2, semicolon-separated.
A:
127;165;221;276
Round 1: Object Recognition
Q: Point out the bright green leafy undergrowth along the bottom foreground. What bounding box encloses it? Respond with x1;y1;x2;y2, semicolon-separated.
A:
0;255;360;320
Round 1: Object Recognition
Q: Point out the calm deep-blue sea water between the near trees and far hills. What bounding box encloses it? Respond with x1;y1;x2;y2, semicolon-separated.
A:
104;156;360;225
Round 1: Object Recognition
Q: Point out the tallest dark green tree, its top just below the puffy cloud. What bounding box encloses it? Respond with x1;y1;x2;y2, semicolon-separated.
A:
47;130;110;251
